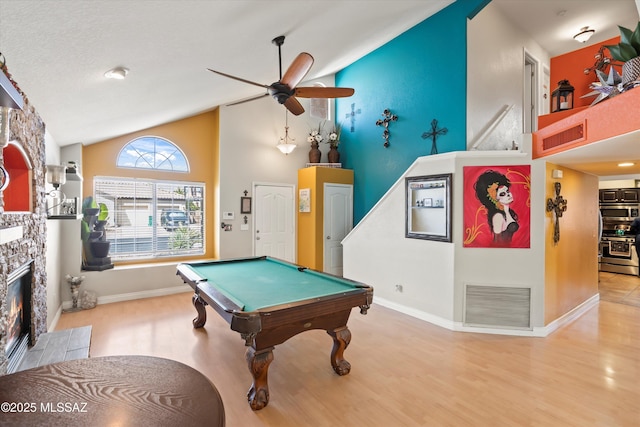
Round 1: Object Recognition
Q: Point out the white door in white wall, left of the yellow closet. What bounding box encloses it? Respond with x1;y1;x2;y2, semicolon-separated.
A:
253;184;295;262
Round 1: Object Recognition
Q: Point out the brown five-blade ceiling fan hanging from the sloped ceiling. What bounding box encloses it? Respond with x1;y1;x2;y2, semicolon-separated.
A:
208;36;355;116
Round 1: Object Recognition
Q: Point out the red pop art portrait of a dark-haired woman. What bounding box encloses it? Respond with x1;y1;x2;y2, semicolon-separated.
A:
463;165;531;248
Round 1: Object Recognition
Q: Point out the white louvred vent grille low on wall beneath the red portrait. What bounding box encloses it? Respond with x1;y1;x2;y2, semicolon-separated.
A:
464;285;531;329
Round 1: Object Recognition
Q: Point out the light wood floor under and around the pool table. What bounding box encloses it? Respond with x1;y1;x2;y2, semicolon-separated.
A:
57;294;640;427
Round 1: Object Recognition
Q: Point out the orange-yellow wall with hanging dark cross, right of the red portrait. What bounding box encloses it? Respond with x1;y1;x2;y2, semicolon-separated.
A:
544;163;599;325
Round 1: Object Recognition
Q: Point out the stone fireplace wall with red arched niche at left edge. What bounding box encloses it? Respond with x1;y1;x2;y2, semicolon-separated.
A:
0;72;47;375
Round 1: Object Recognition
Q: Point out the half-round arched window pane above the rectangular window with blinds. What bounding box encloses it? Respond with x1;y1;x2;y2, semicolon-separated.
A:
116;136;189;172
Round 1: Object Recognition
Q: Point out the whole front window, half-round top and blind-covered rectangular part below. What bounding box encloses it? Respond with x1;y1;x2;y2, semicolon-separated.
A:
93;136;206;262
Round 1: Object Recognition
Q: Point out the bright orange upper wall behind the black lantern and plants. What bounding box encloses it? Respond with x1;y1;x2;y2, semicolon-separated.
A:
552;37;622;110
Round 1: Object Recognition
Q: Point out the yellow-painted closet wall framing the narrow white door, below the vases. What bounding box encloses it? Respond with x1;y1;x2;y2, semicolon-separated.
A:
296;166;353;271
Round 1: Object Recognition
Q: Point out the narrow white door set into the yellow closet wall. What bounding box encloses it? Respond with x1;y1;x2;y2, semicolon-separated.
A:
322;183;353;276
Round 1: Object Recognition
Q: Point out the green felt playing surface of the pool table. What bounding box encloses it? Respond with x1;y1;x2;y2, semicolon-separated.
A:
183;257;363;311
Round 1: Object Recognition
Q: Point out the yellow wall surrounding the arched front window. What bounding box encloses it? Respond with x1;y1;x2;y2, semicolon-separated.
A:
82;109;219;262
